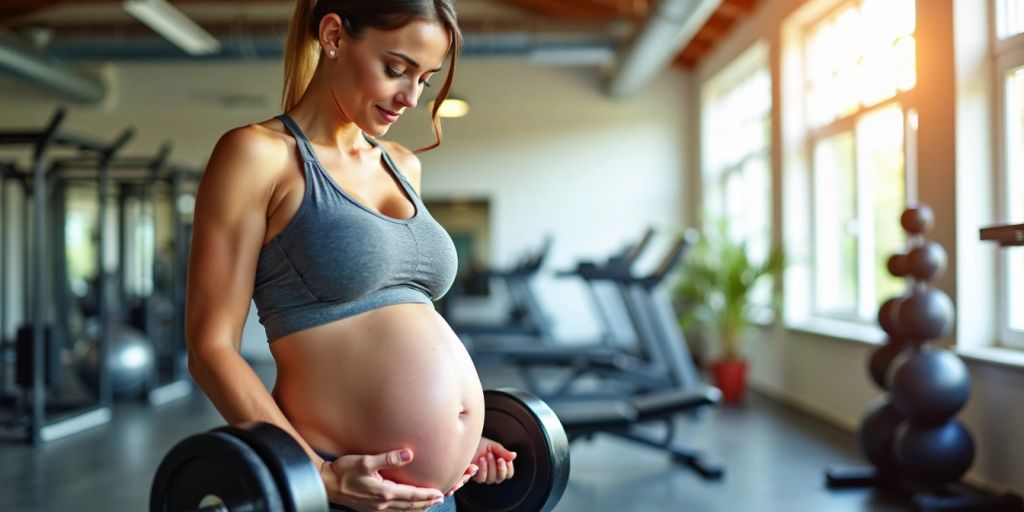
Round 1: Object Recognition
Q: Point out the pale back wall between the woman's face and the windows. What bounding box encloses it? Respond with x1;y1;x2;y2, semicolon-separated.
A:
392;60;686;339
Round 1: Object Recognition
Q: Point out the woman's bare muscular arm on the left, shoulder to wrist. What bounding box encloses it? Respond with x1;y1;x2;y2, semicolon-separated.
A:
185;126;318;452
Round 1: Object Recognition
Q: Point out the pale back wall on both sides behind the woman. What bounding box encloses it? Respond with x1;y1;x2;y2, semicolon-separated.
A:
0;59;686;356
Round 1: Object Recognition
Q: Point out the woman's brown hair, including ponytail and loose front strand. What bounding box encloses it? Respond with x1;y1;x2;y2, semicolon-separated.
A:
282;0;462;153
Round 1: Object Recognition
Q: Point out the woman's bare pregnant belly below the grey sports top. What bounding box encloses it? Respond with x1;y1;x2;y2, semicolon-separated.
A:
270;304;483;492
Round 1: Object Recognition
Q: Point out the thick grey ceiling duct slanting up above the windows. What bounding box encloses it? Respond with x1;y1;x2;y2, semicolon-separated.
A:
606;0;722;97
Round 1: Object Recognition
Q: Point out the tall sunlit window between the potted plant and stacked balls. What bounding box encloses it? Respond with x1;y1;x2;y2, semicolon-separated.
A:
784;0;916;326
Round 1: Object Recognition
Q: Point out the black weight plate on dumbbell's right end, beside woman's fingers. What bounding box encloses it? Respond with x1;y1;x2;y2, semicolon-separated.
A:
456;388;569;512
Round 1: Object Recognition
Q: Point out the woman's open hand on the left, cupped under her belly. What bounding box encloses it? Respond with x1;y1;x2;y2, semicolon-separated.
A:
321;450;444;512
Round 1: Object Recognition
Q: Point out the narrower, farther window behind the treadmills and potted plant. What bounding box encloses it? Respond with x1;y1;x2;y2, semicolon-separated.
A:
701;43;771;258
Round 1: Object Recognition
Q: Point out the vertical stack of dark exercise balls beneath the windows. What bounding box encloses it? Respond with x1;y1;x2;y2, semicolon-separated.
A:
858;205;974;488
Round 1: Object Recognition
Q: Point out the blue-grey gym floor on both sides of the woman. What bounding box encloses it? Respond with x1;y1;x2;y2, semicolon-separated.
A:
0;360;906;512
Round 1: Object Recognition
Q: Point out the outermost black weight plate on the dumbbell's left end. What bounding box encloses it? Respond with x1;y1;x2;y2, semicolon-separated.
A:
150;432;284;512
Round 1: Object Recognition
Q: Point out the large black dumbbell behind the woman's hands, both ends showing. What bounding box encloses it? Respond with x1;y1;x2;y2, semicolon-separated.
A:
150;388;569;512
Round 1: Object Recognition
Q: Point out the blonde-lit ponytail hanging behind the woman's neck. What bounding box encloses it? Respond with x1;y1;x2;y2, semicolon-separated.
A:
281;0;321;112
